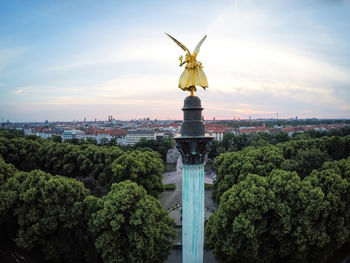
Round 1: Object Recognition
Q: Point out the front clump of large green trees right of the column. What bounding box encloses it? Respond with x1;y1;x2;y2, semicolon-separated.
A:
206;164;350;262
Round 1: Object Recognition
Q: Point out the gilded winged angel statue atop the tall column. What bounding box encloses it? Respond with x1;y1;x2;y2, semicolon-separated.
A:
165;33;208;96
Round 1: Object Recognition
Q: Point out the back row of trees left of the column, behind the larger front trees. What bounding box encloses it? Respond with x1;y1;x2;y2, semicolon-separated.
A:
0;137;164;196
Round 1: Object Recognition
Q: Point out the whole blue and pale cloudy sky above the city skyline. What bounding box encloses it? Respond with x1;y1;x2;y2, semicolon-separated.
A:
0;0;350;122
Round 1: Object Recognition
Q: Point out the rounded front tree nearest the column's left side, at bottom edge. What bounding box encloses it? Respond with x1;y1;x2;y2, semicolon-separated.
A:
89;180;175;263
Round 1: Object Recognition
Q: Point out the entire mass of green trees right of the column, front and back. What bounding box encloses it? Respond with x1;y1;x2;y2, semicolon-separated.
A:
206;135;350;262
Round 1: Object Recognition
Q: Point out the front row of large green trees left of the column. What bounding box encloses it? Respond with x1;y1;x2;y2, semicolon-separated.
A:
0;158;175;262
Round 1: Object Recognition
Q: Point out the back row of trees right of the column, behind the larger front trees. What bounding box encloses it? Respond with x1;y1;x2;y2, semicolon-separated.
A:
212;136;350;202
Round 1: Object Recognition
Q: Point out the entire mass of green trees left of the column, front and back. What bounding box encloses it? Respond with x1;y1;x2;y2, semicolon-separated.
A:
0;132;175;263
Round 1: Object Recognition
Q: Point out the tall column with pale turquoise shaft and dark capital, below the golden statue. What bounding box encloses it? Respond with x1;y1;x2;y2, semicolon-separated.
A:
175;96;212;263
